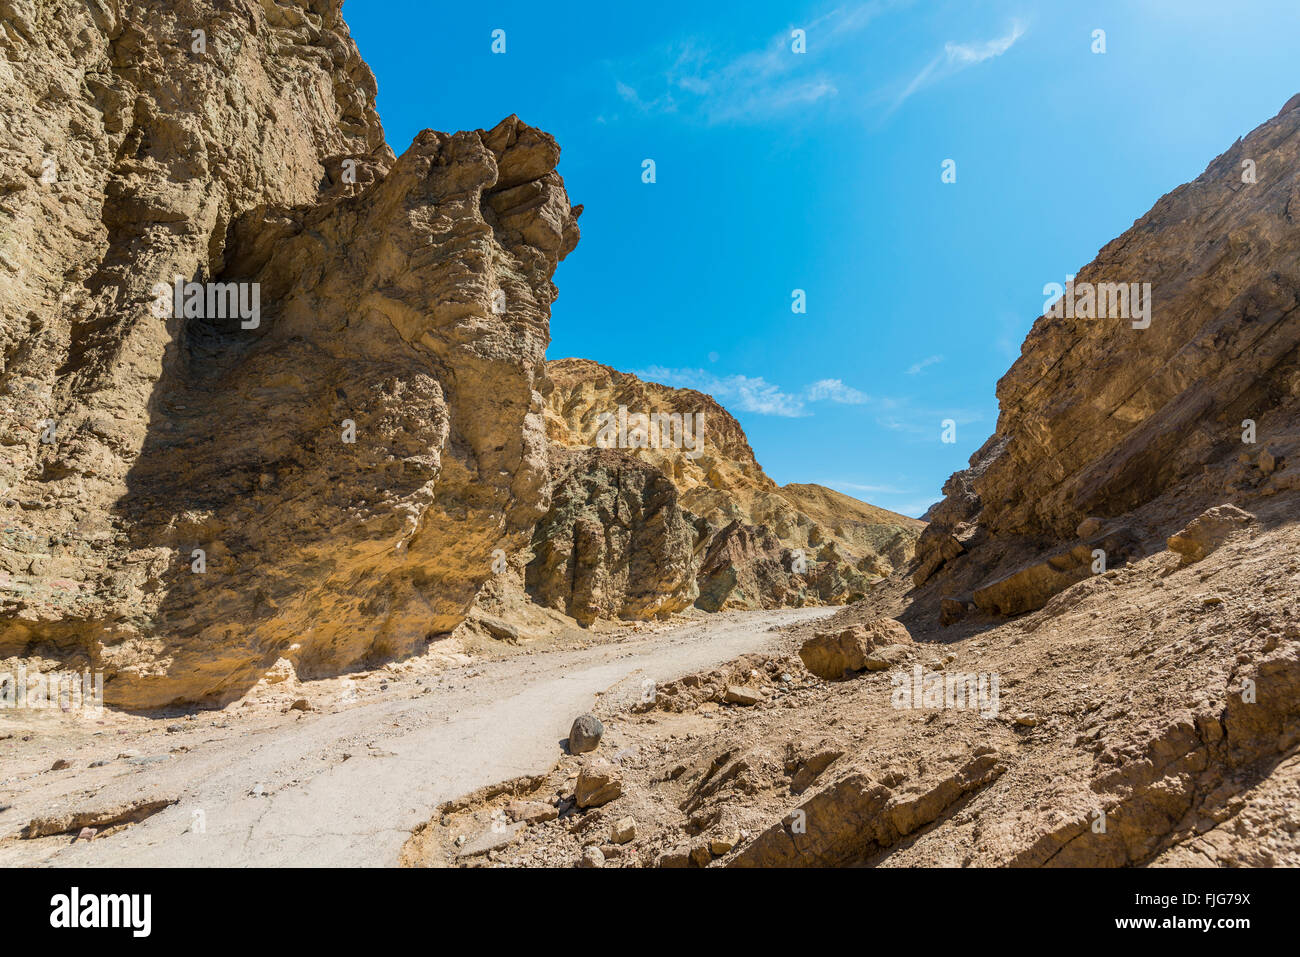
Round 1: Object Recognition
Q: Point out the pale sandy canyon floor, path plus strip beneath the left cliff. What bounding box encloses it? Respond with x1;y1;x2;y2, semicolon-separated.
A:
0;609;836;866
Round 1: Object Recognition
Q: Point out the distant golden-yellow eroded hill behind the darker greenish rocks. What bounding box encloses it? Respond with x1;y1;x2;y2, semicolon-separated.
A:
543;359;924;611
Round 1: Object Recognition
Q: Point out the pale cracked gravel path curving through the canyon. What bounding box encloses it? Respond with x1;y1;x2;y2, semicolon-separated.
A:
0;609;837;867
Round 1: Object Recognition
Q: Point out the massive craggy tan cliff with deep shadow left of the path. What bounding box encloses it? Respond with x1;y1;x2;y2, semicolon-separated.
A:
0;0;580;707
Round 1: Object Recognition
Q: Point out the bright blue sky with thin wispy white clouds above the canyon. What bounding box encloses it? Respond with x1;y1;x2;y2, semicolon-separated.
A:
345;0;1300;515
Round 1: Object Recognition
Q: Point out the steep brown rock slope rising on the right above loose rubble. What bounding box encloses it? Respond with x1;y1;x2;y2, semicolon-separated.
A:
914;100;1300;614
